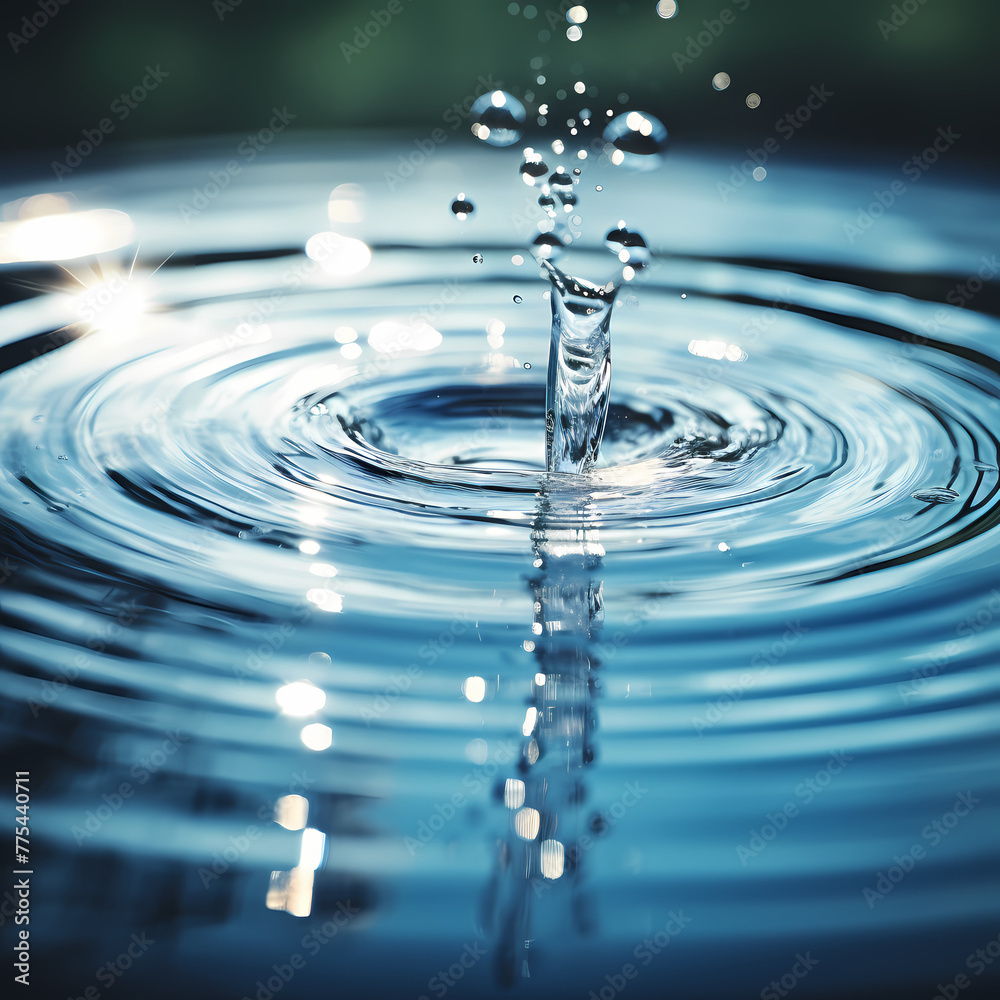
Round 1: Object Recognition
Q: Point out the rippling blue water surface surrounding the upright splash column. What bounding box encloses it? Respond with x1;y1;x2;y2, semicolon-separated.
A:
0;142;1000;1000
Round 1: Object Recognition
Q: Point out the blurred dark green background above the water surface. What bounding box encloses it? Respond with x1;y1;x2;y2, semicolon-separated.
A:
0;0;1000;163
